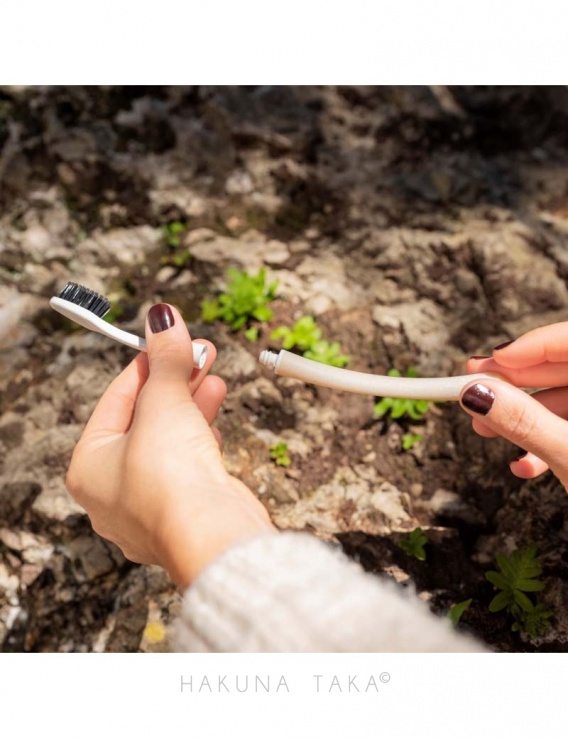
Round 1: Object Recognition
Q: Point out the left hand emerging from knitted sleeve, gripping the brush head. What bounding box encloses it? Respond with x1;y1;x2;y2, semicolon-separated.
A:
66;305;275;587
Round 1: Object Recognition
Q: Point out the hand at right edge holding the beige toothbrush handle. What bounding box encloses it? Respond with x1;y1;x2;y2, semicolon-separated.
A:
461;323;568;489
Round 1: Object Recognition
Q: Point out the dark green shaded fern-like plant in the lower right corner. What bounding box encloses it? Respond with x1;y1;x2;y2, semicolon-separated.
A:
485;545;554;638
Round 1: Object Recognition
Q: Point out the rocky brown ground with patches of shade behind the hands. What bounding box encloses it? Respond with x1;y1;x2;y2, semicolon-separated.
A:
0;87;568;651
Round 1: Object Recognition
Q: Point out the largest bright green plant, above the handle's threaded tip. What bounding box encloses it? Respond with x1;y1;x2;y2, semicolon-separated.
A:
201;267;278;331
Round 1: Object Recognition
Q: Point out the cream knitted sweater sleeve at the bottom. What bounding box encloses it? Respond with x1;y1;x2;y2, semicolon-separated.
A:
177;533;485;653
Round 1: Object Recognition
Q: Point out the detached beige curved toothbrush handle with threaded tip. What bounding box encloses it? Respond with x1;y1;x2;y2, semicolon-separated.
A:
259;349;507;400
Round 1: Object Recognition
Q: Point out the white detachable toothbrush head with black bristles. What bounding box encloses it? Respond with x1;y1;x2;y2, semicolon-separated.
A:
49;282;207;369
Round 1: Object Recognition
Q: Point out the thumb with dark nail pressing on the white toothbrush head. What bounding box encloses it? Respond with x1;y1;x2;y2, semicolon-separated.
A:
146;303;193;388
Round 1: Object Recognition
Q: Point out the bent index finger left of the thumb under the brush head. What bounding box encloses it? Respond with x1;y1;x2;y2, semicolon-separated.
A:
83;353;148;438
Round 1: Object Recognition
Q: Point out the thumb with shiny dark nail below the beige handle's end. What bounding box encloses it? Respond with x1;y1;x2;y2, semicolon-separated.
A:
460;379;568;486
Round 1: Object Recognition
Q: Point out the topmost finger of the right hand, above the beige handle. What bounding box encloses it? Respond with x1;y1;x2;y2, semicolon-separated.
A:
493;322;568;369
